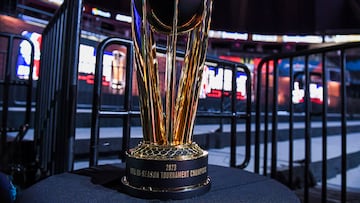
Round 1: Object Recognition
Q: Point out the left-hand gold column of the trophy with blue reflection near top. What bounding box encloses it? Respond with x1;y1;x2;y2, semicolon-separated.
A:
132;0;167;144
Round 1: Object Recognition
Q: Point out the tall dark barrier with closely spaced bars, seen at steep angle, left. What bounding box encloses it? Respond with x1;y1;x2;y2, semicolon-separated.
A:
34;0;83;175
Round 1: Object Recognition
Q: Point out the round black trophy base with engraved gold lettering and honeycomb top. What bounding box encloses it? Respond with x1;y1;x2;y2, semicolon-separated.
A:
121;143;211;200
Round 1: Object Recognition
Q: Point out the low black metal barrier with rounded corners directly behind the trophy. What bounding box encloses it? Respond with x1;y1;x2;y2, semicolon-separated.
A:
90;38;251;168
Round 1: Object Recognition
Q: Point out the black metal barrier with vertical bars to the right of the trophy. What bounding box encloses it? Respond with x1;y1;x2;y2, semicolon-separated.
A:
254;42;360;202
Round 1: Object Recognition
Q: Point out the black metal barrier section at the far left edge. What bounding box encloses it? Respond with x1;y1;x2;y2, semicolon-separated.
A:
0;33;35;179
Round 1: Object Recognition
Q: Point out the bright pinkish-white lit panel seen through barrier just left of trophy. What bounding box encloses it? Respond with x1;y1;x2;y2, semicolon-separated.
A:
111;47;126;90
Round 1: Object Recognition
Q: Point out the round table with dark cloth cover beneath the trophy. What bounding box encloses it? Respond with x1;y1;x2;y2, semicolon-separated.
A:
17;164;300;203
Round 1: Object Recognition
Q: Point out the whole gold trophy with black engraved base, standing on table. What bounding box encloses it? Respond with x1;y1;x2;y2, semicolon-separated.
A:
121;0;212;199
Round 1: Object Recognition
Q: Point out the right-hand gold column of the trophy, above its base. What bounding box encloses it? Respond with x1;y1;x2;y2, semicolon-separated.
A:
175;1;212;143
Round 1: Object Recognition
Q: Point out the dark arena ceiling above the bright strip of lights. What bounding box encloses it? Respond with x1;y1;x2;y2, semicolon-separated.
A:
0;0;360;35
